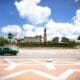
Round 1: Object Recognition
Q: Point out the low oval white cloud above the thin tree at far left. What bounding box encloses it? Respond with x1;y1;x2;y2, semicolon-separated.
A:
1;25;22;33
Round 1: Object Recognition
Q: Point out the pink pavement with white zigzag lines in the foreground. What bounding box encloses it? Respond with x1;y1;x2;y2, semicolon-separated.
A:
0;58;80;80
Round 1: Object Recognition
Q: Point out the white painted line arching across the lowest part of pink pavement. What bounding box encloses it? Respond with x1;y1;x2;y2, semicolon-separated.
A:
2;70;56;80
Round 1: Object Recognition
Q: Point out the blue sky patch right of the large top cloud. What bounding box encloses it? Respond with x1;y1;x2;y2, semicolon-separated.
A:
42;0;80;22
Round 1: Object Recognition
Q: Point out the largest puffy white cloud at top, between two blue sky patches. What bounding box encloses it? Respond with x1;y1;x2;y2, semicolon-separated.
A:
15;0;51;24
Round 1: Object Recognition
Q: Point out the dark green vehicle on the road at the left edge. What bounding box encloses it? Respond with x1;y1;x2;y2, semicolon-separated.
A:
0;47;18;55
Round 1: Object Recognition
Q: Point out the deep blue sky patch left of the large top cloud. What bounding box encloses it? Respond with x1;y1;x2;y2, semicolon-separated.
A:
0;0;25;27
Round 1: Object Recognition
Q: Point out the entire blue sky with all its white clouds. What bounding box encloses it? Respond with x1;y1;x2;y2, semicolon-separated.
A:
0;0;80;40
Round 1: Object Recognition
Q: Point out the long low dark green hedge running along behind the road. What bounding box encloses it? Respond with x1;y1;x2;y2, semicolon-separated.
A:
17;42;76;47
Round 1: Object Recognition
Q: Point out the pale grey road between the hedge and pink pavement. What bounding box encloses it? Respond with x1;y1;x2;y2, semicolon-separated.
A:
0;48;80;60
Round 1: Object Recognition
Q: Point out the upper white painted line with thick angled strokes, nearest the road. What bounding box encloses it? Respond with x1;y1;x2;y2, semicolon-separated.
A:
0;58;80;70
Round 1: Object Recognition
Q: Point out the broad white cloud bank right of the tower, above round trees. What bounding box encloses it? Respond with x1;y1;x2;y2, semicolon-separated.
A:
46;20;80;40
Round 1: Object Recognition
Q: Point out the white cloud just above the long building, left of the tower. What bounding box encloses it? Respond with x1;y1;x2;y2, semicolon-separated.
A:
23;24;44;36
